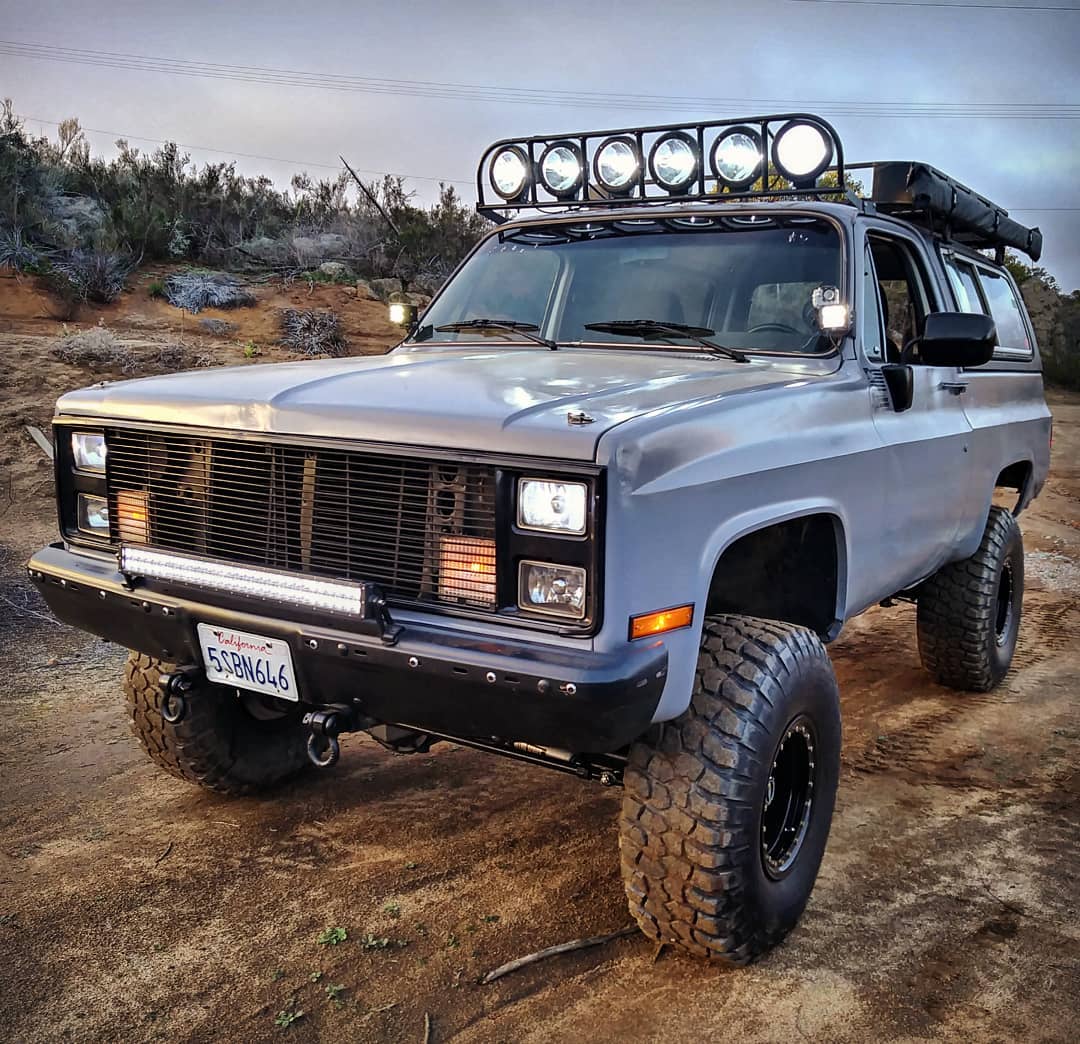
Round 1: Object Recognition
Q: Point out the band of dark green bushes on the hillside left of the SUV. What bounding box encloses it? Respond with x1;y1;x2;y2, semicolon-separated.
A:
0;99;485;301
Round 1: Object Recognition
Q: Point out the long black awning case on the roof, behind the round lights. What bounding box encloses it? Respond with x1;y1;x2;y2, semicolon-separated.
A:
849;161;1042;262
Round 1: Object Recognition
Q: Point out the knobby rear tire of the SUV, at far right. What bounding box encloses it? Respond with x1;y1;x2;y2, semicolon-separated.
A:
917;507;1024;692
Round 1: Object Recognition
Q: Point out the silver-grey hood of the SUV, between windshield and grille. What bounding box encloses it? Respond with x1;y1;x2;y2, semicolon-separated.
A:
57;347;836;460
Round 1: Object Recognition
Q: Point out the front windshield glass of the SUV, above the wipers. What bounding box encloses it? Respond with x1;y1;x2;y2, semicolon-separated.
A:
414;215;841;352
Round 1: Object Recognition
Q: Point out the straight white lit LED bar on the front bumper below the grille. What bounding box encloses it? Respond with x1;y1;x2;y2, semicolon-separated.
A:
120;544;367;616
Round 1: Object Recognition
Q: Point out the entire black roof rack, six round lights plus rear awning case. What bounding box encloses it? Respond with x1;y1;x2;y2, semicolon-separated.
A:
476;112;1042;261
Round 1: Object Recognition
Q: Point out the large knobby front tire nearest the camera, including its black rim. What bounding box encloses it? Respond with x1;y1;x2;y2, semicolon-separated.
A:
619;615;840;964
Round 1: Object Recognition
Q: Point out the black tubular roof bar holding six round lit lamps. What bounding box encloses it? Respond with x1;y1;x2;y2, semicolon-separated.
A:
476;112;845;221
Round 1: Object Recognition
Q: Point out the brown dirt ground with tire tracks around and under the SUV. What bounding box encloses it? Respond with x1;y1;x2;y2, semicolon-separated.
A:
0;275;1080;1042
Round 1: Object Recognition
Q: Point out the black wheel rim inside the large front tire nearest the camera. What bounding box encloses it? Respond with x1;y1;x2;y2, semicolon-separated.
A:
761;717;815;878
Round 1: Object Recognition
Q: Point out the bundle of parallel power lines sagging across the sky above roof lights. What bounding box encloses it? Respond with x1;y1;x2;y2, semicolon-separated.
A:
0;40;1080;120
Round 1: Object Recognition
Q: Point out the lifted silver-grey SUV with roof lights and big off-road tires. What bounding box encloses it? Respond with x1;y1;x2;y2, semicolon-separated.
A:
29;113;1051;963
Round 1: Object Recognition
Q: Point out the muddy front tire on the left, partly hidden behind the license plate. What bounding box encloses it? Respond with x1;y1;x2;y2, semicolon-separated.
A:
124;652;310;795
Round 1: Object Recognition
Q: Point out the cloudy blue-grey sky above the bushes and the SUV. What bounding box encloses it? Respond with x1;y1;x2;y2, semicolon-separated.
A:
0;0;1080;289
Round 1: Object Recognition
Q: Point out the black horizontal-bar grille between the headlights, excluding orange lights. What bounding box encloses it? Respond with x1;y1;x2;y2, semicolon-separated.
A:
106;429;495;609
